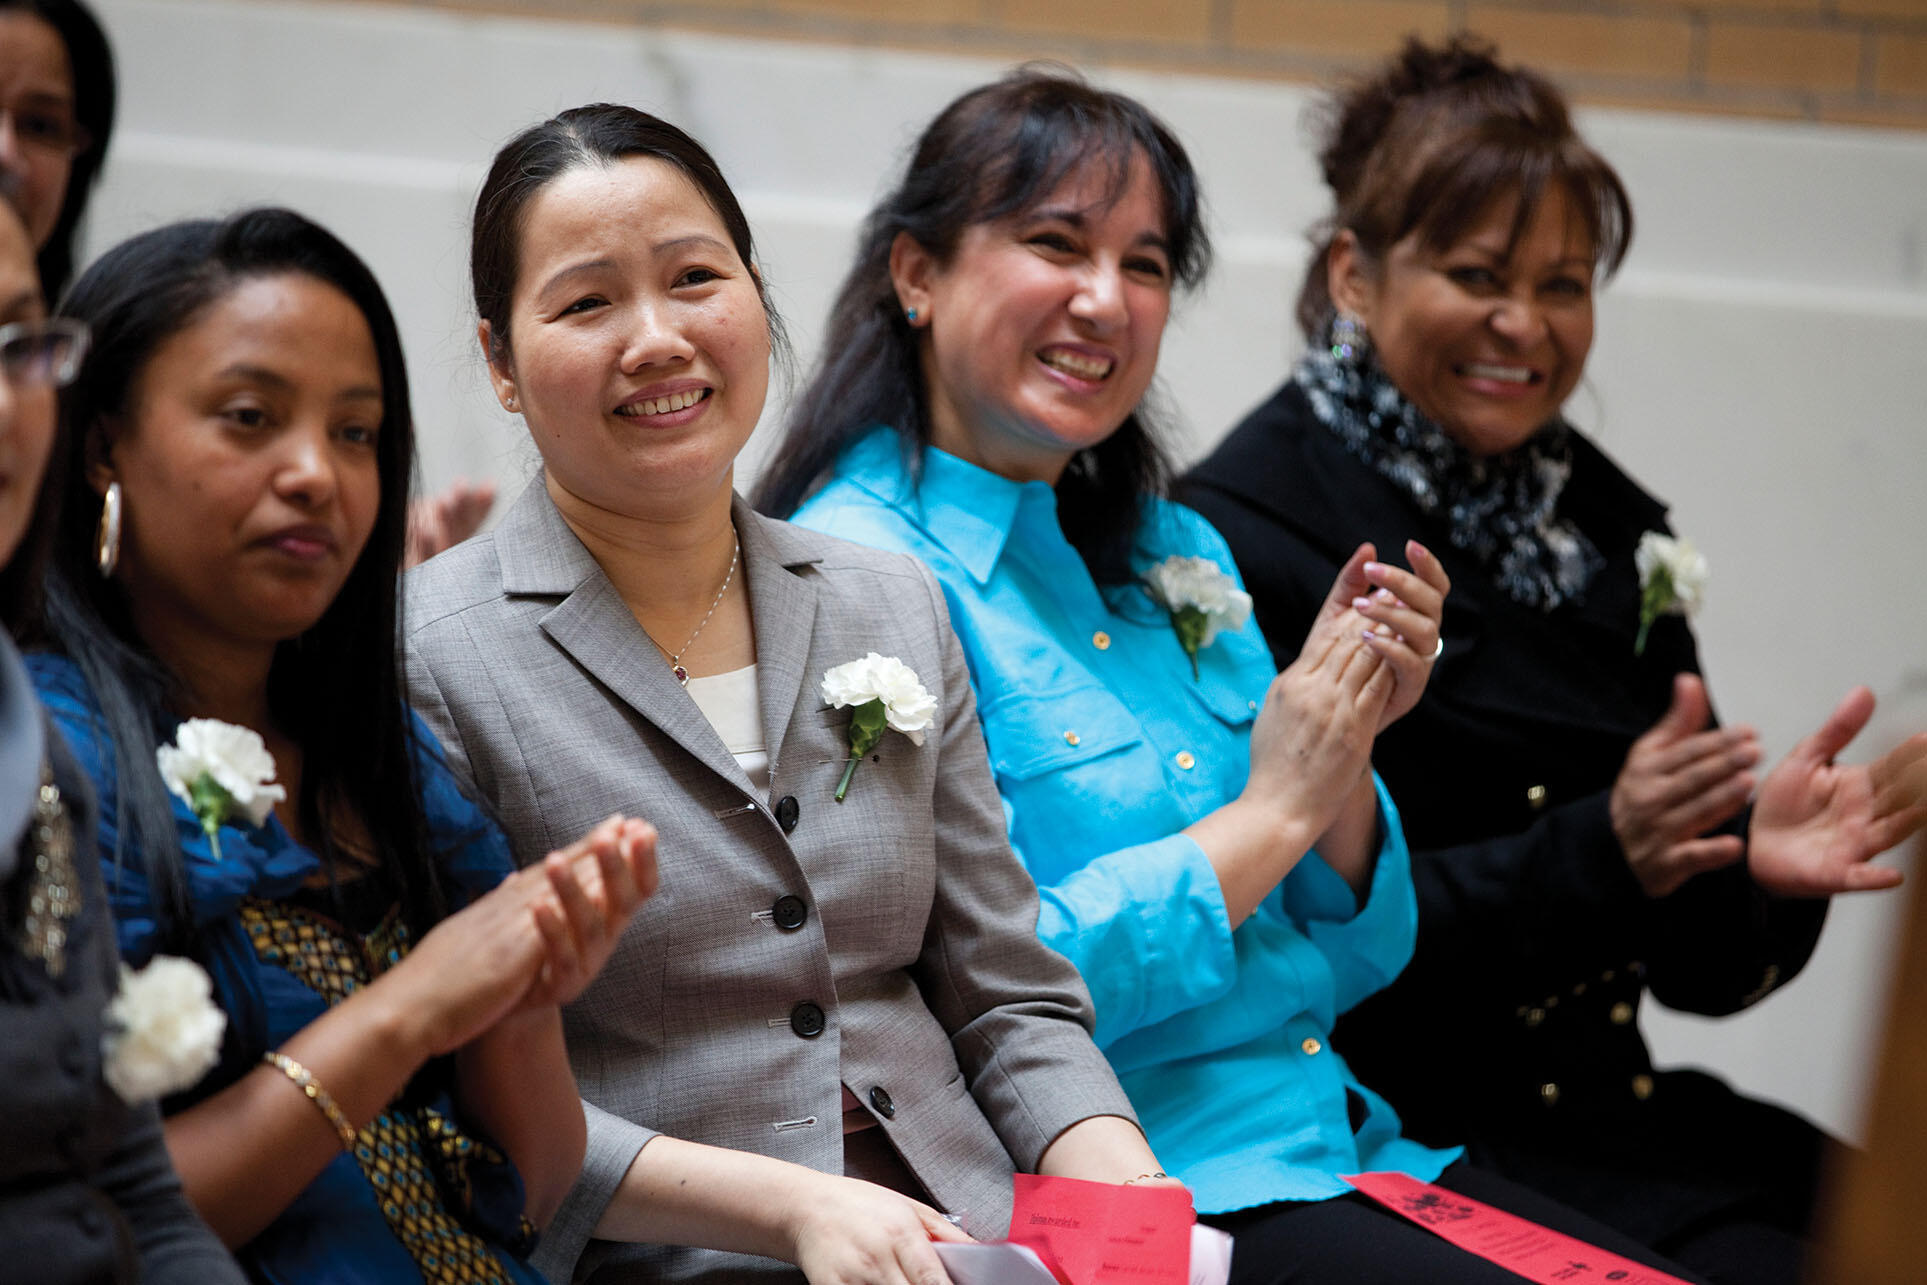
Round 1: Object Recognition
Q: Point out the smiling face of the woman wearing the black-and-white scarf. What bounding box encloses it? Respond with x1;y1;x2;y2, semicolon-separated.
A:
1330;185;1594;455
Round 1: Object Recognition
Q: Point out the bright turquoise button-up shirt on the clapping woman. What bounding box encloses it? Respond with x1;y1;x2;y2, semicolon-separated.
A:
794;428;1459;1214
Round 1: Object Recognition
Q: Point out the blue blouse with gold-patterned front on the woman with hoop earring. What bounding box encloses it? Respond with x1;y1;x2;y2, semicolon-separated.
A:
27;655;541;1285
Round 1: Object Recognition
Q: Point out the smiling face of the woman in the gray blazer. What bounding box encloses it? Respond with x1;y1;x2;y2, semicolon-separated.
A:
482;156;769;518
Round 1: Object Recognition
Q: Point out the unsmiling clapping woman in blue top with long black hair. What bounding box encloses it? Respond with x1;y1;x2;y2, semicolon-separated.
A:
31;210;653;1281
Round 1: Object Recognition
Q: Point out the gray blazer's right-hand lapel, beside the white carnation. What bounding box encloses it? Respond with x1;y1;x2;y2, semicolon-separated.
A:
732;497;824;780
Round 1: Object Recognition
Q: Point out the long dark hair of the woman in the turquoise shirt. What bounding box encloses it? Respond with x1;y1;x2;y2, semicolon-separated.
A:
755;66;1210;584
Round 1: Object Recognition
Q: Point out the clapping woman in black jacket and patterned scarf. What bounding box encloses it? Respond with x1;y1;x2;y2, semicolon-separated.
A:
1179;40;1927;1285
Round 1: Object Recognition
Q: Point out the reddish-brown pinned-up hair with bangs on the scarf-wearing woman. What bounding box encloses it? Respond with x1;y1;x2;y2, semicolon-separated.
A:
1297;35;1632;337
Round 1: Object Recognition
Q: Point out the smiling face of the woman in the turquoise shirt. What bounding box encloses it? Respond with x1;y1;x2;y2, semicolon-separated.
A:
890;154;1172;484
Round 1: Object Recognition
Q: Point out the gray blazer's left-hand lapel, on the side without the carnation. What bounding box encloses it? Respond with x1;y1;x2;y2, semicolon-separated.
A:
495;474;767;796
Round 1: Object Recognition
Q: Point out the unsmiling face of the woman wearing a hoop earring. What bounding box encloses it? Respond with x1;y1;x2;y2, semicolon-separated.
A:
91;274;382;655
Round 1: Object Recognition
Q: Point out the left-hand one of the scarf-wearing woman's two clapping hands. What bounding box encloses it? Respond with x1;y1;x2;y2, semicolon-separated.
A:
1609;674;1759;898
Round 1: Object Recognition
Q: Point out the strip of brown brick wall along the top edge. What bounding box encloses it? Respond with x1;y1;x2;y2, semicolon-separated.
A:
375;0;1927;129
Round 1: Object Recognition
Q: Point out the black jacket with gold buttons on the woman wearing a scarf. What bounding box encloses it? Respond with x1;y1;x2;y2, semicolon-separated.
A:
1177;383;1825;1241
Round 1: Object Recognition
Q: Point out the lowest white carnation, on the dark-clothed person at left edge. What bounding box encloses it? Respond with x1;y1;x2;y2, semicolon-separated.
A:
100;956;227;1106
